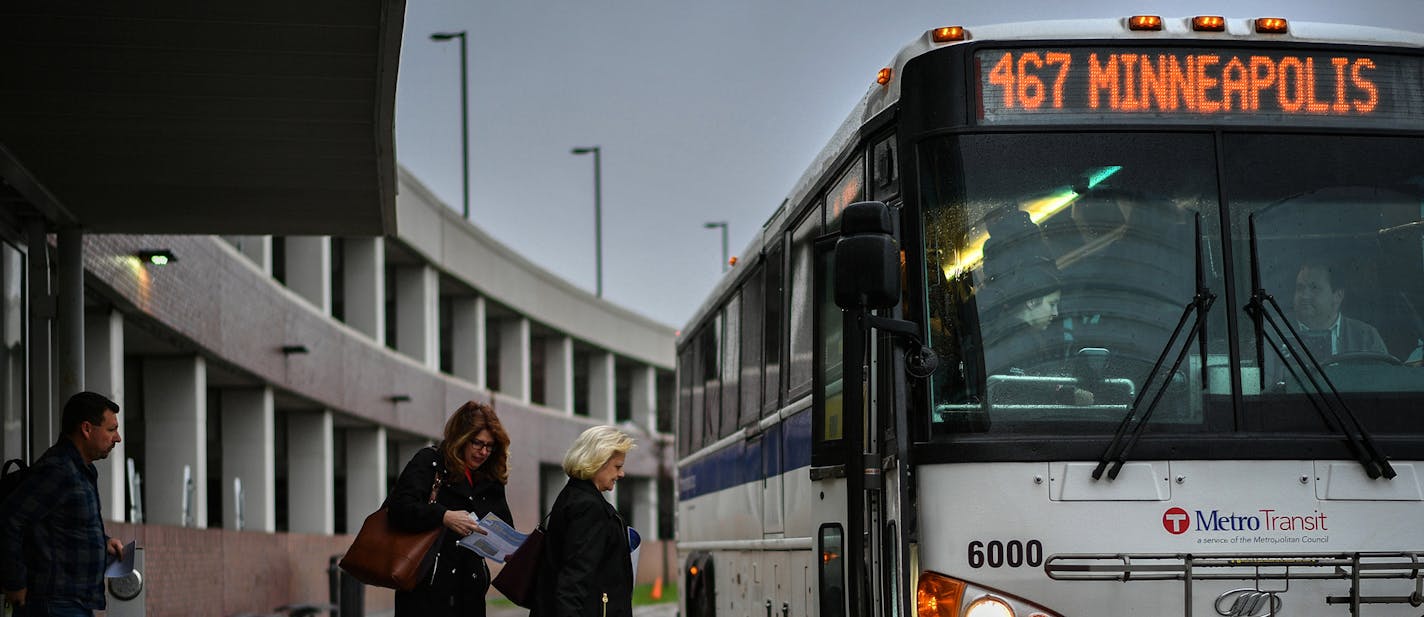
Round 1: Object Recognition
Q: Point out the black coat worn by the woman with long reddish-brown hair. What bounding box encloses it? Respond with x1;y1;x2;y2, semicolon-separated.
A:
387;447;514;617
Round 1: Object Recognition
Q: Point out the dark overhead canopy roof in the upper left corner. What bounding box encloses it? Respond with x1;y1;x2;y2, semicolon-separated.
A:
0;0;406;235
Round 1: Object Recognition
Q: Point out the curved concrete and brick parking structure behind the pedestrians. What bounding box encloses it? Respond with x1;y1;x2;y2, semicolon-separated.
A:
47;167;675;616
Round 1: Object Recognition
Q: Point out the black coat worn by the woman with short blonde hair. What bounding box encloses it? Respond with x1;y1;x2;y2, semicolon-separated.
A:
530;479;632;617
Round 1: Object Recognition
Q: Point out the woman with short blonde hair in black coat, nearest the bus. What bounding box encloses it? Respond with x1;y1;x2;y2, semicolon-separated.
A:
530;426;634;617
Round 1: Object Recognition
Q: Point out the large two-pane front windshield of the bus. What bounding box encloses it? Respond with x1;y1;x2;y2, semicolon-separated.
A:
920;133;1424;436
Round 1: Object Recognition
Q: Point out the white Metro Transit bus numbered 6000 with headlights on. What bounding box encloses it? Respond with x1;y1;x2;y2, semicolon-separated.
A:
676;16;1424;617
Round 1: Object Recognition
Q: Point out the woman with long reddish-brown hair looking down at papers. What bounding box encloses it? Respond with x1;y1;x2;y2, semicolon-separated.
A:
387;400;514;617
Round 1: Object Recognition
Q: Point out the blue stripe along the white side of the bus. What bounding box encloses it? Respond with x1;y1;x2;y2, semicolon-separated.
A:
678;410;810;499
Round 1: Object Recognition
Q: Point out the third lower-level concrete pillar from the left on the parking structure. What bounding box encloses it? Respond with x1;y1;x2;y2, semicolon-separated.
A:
221;388;276;533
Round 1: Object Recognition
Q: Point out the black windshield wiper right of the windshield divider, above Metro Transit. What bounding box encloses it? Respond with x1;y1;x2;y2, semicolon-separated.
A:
1245;214;1396;479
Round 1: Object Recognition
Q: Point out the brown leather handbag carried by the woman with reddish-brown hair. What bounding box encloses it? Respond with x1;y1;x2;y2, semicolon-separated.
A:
340;472;444;591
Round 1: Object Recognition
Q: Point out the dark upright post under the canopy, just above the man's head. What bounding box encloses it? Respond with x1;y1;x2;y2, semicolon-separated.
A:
54;228;85;404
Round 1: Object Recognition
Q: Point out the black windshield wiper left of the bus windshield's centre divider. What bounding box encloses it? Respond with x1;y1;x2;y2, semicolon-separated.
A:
1092;212;1216;480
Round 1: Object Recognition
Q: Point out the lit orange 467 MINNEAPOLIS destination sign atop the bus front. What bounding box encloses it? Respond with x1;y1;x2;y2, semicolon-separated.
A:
975;47;1424;130
